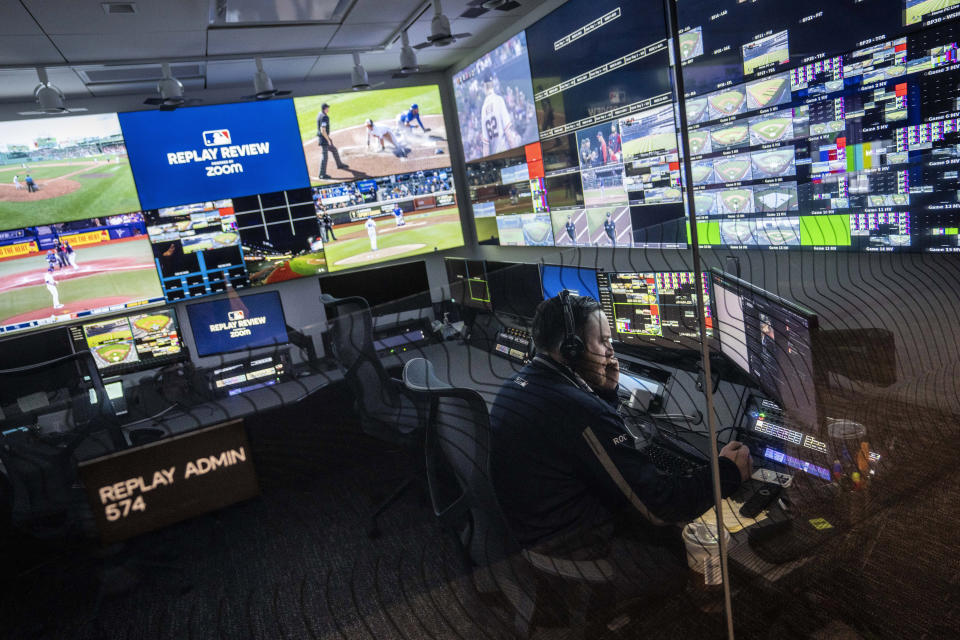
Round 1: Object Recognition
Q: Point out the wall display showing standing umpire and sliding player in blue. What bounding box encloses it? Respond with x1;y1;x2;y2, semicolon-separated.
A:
294;85;450;185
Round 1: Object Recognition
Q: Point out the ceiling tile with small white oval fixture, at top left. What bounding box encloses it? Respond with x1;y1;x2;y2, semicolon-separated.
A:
23;0;210;35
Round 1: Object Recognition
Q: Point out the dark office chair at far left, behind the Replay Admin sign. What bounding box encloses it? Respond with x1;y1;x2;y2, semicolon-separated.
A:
0;351;118;539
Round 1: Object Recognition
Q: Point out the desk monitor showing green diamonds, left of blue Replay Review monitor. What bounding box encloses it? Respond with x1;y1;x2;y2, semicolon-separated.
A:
70;308;186;375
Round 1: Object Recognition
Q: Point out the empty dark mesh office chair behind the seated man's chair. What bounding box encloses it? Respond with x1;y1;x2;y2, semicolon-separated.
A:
320;294;425;538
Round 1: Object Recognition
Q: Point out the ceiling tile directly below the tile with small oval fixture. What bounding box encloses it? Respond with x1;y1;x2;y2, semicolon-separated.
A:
51;31;204;63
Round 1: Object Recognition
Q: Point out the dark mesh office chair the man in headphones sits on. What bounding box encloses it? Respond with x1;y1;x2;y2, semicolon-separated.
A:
403;358;614;638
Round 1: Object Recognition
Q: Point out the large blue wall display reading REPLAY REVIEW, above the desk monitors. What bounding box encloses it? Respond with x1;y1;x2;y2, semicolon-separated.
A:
120;100;309;209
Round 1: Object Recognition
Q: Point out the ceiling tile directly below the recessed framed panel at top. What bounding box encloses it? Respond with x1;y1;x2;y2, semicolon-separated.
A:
207;25;337;56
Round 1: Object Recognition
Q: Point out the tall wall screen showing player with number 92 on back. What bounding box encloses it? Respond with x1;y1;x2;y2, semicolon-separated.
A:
453;31;540;162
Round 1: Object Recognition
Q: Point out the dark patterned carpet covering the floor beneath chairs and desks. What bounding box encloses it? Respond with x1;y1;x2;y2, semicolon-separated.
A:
0;382;960;640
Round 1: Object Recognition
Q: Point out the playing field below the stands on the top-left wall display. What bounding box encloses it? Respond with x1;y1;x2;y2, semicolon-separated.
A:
0;155;140;229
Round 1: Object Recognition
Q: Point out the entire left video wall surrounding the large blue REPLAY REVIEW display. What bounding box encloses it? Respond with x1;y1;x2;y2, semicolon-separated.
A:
0;86;463;335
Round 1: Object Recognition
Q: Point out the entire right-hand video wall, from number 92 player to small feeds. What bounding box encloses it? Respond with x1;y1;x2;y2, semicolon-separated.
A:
454;0;960;252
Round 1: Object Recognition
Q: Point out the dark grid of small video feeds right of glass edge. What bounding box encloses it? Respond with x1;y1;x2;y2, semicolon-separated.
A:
678;0;960;252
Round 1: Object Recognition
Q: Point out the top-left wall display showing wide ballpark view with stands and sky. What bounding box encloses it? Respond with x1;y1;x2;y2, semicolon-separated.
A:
0;113;140;229
